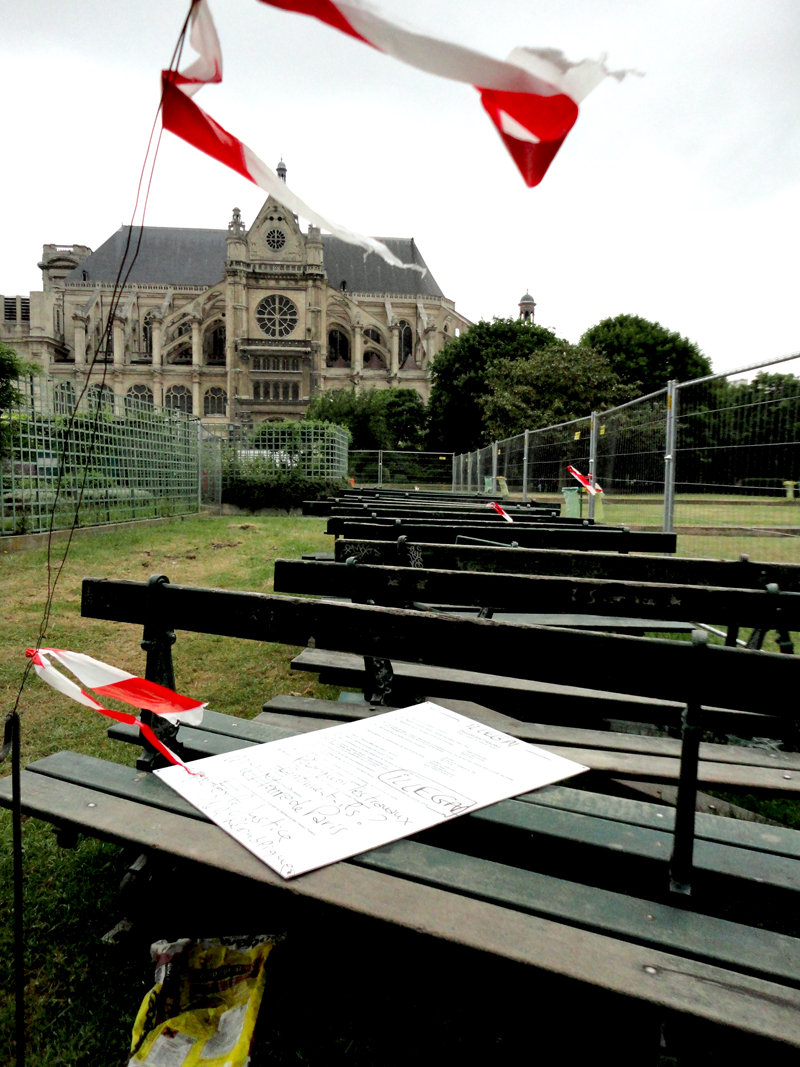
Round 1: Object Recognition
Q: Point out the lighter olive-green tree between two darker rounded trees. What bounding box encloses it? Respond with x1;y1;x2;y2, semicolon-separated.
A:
481;343;638;440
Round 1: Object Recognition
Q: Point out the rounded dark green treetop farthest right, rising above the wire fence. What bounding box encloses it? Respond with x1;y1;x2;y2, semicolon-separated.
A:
578;315;711;395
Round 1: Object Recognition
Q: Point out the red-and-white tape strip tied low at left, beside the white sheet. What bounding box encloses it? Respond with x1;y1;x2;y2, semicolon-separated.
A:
26;649;206;775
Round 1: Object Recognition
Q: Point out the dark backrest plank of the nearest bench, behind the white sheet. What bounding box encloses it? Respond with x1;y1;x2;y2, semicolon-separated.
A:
81;578;800;721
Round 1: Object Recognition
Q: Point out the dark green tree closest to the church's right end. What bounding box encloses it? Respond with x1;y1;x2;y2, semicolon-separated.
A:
428;319;566;452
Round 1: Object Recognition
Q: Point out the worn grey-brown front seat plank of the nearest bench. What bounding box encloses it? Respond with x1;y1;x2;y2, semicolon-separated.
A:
0;773;800;1047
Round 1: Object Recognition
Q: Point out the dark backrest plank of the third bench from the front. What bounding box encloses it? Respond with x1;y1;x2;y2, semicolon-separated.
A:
334;538;800;593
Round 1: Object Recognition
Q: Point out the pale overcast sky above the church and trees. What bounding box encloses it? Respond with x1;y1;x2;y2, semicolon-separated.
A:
0;0;800;370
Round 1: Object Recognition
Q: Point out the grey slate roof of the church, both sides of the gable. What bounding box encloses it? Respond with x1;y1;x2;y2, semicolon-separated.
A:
65;226;444;297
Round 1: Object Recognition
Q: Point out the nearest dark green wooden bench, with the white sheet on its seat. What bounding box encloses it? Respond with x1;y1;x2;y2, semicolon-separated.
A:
0;579;800;1047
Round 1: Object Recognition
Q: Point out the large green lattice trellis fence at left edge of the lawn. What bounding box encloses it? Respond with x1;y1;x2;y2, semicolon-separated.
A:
0;377;199;535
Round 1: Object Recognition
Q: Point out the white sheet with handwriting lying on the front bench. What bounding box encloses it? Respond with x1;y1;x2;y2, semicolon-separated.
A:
155;703;587;878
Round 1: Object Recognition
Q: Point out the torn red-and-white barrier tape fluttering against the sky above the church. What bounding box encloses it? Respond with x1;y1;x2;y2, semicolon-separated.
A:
162;0;634;245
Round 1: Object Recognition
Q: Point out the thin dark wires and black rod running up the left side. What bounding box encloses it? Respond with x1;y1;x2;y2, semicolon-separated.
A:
0;6;197;1067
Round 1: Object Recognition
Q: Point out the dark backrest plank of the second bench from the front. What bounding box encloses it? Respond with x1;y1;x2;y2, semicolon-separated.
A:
274;559;800;630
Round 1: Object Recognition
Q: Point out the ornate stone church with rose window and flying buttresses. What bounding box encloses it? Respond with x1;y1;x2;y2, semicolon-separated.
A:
0;168;469;424
